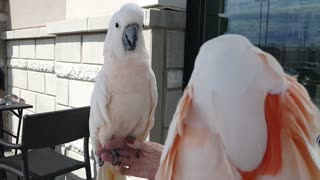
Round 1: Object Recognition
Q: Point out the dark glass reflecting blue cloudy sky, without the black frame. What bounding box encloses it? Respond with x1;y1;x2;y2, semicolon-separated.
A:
211;0;320;107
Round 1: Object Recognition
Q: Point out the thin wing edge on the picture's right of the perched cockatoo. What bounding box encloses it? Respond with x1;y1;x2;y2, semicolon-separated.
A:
141;70;158;140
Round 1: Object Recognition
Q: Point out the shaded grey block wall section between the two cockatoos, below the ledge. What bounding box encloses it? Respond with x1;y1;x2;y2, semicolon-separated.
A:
151;29;184;143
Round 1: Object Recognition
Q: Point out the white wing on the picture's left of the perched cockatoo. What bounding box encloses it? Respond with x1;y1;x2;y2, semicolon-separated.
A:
89;70;111;151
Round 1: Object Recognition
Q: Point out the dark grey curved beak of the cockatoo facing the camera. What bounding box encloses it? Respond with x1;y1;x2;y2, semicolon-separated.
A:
122;24;139;51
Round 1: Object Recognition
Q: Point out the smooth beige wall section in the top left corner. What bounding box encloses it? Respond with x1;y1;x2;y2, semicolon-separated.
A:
8;0;66;29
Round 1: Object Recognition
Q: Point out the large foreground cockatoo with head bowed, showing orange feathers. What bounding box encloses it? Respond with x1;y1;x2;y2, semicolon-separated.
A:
156;35;320;180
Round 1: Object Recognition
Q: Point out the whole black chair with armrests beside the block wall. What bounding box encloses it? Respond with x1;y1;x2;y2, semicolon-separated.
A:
0;107;91;180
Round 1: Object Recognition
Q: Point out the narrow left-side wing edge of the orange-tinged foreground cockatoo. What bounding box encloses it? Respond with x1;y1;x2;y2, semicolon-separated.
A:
156;87;192;179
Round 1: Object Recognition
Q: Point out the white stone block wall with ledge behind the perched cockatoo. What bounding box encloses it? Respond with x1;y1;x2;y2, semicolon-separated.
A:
2;9;185;178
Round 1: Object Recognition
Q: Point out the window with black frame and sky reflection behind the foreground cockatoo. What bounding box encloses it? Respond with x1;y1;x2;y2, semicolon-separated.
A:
184;0;320;107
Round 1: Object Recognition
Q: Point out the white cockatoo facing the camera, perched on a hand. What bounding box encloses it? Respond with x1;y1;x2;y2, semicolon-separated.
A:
89;3;157;180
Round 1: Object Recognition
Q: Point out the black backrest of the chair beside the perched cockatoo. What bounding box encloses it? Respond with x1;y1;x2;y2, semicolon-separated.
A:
22;107;90;149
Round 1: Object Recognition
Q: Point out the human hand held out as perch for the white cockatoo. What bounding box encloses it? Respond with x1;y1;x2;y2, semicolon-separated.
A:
97;139;163;179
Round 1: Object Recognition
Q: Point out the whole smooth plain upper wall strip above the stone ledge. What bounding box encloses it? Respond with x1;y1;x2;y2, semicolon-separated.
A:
6;0;186;30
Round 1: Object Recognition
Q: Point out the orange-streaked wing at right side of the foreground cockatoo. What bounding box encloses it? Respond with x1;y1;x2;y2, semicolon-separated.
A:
279;76;320;180
